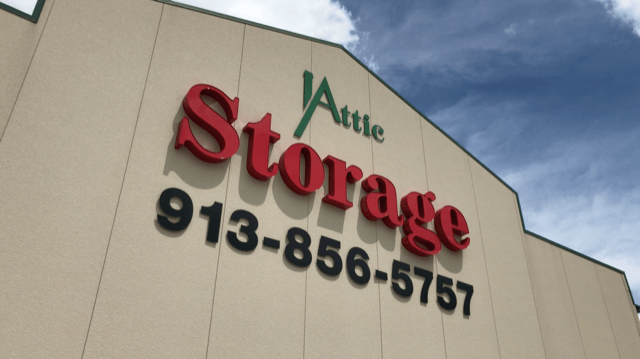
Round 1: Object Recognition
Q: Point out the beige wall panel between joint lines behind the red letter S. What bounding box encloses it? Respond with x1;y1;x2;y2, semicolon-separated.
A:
85;6;244;358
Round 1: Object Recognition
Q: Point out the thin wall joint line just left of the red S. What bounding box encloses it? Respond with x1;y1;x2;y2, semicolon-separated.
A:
81;4;164;357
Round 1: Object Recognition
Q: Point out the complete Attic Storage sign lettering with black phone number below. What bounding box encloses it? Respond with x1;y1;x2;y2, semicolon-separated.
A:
157;71;473;315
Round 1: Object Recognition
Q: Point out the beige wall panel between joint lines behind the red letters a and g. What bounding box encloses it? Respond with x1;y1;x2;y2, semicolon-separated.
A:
367;75;448;358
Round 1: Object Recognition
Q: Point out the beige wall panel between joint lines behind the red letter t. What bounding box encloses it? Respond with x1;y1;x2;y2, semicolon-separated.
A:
209;26;318;358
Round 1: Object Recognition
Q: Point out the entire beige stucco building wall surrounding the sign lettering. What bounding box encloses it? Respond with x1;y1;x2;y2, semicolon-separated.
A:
0;0;640;358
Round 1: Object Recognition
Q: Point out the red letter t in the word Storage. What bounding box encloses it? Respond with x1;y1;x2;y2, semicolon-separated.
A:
243;113;280;181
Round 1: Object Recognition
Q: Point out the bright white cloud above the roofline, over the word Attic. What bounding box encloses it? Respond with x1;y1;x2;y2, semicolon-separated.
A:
176;0;360;50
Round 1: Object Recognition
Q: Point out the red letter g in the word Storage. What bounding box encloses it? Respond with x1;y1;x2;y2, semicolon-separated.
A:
400;192;441;257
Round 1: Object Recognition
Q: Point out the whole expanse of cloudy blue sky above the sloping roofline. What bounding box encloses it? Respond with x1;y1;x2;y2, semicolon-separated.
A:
175;0;640;304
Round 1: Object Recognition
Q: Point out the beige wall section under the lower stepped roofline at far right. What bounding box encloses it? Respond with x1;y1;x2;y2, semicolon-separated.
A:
525;234;640;358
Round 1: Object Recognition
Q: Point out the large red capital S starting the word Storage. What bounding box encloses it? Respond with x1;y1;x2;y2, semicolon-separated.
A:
175;84;240;163
